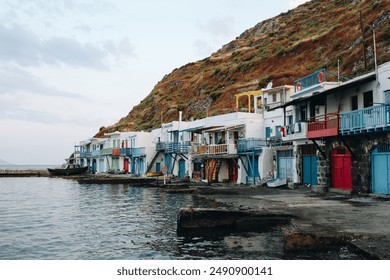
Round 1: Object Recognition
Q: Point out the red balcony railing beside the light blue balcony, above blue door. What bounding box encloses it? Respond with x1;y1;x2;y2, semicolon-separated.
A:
307;113;340;139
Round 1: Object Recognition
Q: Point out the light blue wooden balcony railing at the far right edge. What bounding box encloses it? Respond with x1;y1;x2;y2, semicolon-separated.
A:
340;104;390;135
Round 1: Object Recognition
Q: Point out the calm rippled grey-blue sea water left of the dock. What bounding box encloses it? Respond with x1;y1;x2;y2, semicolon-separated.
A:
0;177;266;259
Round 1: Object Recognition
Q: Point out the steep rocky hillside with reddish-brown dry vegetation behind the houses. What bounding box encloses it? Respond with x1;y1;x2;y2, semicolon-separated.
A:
97;0;390;136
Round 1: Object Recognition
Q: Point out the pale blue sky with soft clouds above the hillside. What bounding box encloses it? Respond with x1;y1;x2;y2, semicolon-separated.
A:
0;0;307;165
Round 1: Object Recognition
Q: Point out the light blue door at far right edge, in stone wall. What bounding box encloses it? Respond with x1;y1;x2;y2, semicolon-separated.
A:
371;145;390;194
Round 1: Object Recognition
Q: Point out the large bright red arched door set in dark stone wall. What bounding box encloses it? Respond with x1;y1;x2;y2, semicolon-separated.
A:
332;147;352;190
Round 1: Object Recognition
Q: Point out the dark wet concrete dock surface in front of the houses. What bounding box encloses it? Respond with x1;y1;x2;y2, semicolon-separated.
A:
193;185;390;260
